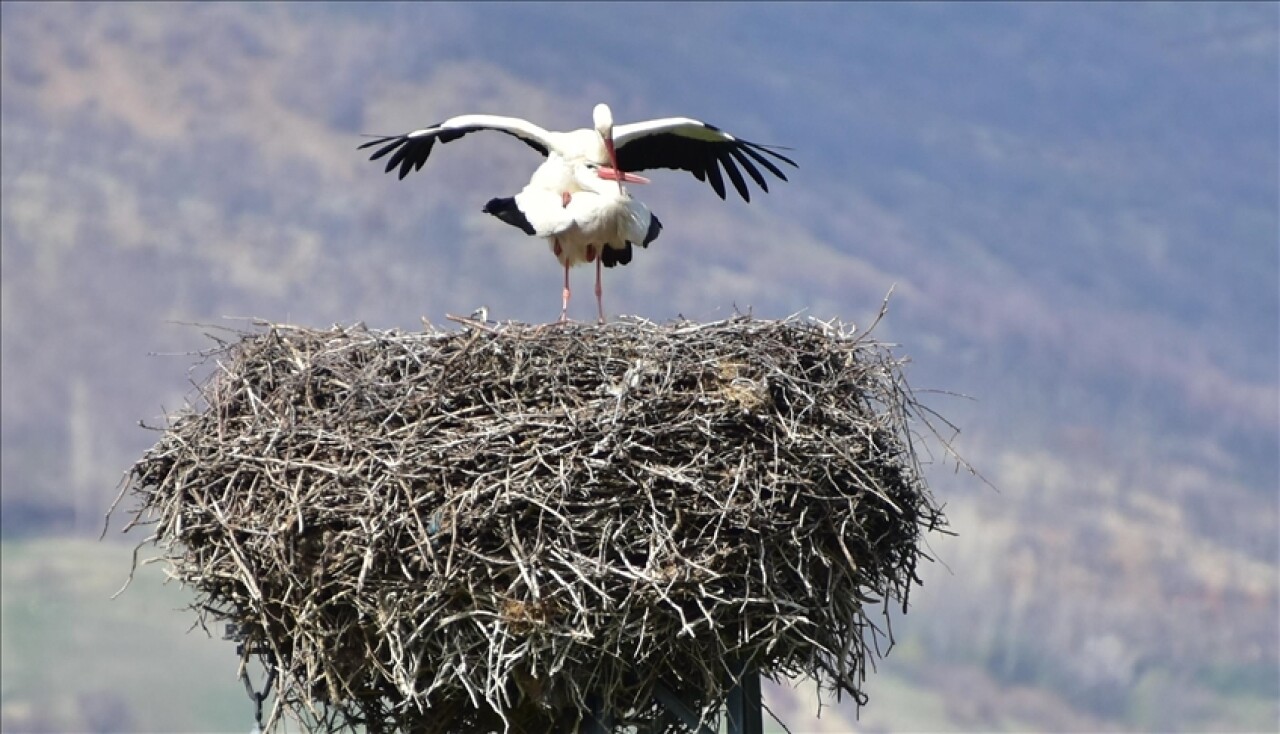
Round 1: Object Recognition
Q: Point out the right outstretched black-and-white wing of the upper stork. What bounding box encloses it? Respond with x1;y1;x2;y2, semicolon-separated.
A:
613;118;796;201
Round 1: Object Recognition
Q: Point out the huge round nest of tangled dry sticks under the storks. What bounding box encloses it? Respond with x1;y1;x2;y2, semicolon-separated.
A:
117;316;943;731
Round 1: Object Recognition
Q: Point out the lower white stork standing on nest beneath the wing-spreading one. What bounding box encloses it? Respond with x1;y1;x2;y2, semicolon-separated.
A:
483;161;662;324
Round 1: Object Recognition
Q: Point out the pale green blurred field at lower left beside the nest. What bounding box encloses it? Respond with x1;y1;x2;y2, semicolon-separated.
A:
0;538;253;731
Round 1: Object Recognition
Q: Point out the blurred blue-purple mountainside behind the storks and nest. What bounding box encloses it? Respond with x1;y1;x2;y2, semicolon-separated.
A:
0;3;1280;731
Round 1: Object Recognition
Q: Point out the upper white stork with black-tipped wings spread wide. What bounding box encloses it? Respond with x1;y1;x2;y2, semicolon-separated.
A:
360;104;795;201
